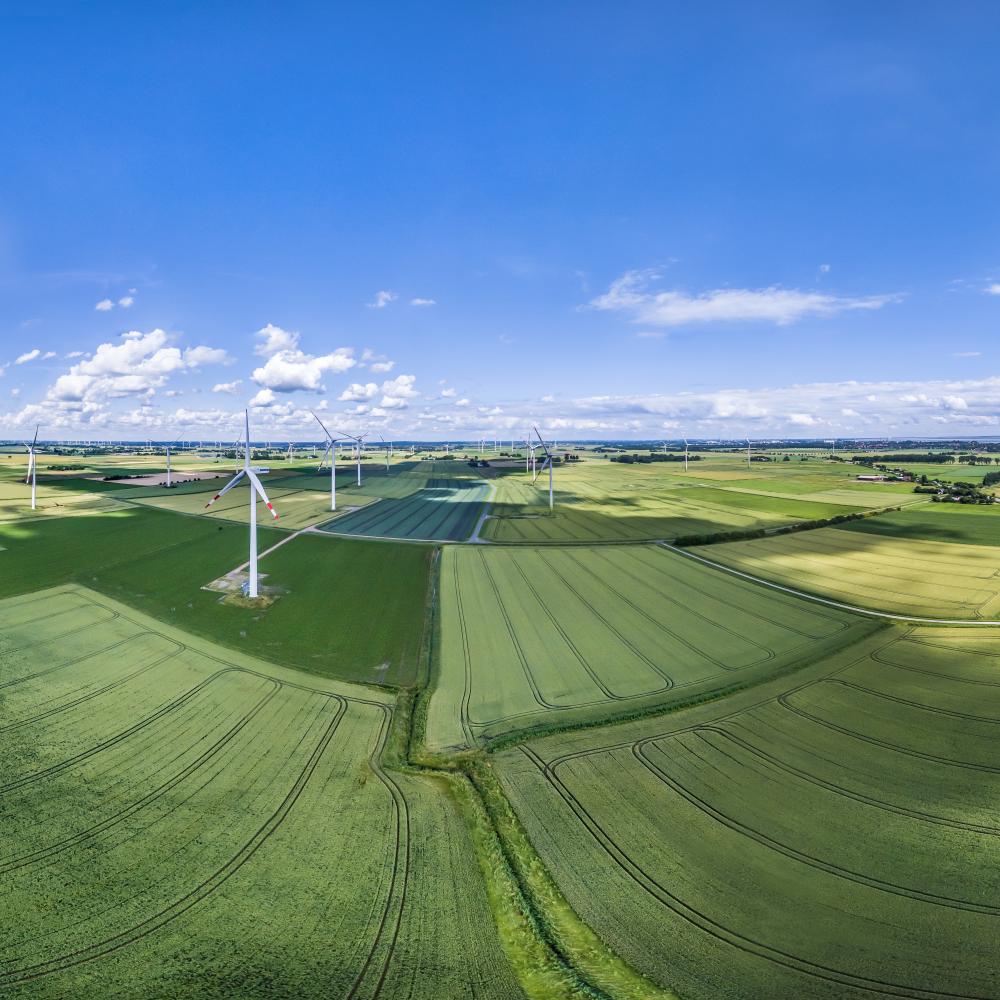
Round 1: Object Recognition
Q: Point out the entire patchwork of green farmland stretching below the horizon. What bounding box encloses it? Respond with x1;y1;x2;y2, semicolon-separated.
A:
0;452;1000;1000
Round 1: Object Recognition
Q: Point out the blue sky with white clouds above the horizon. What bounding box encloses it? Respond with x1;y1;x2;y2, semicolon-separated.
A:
0;2;1000;438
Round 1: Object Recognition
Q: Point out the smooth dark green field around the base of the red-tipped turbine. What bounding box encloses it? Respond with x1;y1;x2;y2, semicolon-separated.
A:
0;508;430;684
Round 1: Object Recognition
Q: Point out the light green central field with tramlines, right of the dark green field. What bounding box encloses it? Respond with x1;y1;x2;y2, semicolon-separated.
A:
428;545;867;748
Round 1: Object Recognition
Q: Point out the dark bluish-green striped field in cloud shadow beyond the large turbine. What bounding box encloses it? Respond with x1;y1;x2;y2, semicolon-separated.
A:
320;479;490;542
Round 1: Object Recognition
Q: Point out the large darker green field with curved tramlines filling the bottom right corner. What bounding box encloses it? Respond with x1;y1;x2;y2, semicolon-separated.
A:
496;626;1000;1000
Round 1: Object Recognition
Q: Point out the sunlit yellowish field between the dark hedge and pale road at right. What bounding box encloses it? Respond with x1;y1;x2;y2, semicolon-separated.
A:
692;520;1000;621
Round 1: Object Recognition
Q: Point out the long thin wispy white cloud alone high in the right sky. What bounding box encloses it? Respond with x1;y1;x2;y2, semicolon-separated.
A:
590;271;901;327
